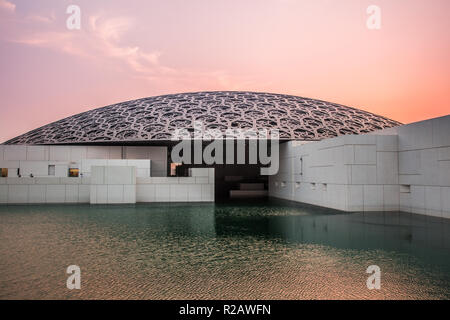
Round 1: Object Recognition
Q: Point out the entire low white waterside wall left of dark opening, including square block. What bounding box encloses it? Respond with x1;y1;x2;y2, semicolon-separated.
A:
0;166;214;204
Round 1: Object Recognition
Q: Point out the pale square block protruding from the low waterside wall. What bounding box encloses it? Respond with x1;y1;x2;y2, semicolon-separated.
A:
90;166;136;204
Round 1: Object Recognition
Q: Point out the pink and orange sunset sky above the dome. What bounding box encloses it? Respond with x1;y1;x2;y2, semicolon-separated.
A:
0;0;450;142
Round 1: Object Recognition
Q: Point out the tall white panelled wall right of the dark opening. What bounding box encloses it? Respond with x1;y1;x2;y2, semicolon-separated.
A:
269;116;450;218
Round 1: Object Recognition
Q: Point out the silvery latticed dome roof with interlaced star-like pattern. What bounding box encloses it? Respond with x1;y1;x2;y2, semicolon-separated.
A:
5;91;400;144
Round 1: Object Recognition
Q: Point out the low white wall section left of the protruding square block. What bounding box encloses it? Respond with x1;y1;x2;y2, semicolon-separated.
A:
0;177;90;204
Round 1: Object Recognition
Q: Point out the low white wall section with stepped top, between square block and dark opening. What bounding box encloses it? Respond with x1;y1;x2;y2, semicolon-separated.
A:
136;168;214;202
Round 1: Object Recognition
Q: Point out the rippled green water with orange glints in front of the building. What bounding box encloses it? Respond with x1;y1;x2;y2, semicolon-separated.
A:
0;202;450;299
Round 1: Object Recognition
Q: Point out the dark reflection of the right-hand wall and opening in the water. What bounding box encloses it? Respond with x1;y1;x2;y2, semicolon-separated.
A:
216;201;450;270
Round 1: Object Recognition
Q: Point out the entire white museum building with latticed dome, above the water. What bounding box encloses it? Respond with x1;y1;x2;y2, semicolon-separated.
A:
0;91;450;218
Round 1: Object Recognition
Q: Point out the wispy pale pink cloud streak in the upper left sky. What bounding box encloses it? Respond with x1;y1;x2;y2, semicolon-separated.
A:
0;6;246;89
